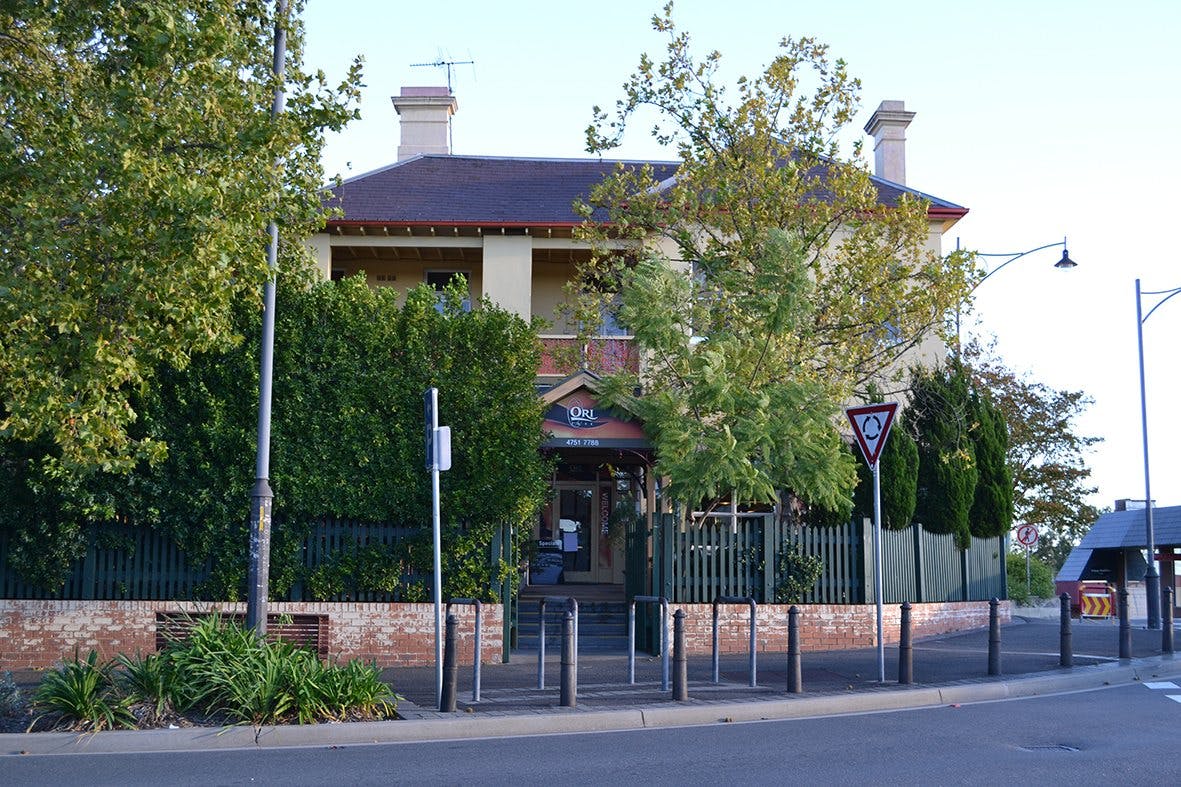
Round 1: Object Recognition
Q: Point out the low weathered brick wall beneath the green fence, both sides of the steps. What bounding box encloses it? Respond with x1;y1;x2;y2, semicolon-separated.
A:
0;600;1012;669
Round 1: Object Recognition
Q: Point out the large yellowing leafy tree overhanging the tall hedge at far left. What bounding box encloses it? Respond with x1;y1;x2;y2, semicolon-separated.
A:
0;0;359;472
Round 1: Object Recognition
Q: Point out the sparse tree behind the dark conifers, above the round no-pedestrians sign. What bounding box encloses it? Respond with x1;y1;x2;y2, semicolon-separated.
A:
964;342;1102;567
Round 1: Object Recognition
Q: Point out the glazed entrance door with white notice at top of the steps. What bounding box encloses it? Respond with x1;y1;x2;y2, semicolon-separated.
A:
549;483;624;583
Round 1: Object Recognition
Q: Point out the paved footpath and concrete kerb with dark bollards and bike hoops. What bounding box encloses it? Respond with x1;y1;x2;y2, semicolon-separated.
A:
0;612;1181;755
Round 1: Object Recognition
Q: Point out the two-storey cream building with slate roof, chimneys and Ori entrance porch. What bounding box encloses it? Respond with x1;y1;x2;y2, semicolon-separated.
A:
311;87;967;584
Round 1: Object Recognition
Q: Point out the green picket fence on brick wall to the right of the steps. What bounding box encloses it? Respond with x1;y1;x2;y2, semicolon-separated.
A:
647;514;1005;604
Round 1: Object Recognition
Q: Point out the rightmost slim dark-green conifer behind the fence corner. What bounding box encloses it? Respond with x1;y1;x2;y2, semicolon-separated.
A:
968;391;1013;538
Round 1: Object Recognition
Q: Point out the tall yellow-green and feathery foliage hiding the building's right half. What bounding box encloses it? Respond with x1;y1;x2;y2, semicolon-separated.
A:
573;4;968;514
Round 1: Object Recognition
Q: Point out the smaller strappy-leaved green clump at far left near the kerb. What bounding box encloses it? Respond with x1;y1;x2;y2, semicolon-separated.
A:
28;650;136;733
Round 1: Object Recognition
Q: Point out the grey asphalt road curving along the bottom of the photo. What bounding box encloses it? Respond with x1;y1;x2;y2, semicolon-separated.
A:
9;683;1181;787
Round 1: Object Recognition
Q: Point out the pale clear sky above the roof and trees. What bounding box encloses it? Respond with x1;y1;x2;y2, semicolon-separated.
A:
305;0;1181;506
